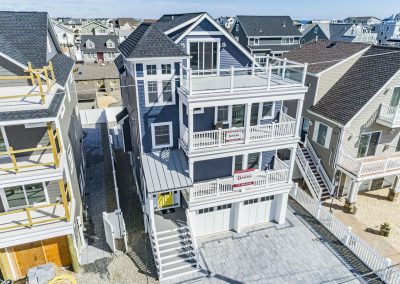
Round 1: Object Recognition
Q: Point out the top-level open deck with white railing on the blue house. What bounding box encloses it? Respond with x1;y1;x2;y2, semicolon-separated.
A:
180;57;307;97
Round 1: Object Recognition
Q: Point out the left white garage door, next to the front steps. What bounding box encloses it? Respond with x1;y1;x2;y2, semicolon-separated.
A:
192;204;234;237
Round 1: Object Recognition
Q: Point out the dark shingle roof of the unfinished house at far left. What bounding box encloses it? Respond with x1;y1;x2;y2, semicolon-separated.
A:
0;11;74;86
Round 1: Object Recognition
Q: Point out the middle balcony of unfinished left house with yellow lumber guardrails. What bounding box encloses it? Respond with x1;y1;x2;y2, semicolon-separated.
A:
0;123;62;184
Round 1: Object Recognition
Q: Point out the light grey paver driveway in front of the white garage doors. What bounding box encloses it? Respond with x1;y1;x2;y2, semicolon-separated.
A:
198;207;358;283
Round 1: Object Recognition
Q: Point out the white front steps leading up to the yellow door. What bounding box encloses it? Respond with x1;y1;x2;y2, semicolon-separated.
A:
151;222;199;280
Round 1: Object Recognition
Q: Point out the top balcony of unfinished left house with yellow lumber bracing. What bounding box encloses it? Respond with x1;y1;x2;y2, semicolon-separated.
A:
0;61;57;112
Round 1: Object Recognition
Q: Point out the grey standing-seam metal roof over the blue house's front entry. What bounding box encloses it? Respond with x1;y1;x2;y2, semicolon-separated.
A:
142;149;193;192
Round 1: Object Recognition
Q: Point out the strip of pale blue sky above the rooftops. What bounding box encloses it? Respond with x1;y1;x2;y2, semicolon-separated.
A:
0;0;400;19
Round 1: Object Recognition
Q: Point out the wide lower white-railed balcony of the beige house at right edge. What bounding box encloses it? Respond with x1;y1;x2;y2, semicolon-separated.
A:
339;153;400;178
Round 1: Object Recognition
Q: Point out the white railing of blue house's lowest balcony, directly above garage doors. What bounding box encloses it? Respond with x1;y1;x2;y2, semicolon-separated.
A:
189;156;289;201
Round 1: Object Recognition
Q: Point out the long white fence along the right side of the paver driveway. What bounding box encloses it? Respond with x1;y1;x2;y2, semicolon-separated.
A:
290;184;400;284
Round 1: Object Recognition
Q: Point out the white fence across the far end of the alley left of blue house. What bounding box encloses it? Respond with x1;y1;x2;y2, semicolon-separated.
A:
79;107;122;125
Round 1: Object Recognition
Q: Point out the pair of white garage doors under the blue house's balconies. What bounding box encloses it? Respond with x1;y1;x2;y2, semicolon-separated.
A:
191;196;276;237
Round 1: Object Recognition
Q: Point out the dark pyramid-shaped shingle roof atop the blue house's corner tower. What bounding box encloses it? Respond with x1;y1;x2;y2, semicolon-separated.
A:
118;23;187;58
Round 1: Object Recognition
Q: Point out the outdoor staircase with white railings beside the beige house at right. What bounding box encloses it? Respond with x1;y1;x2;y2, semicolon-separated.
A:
296;138;333;201
